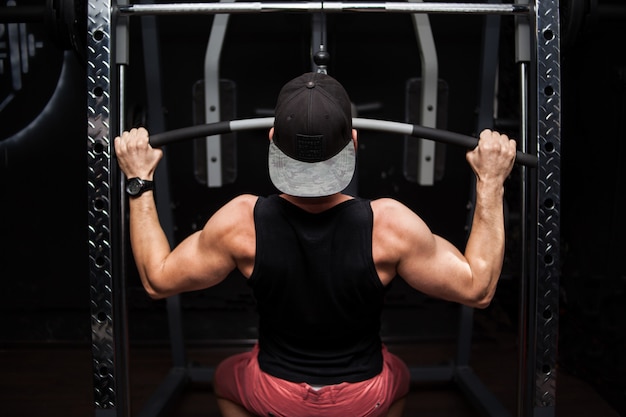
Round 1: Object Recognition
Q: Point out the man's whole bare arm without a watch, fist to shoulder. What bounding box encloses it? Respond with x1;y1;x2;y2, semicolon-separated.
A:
372;131;515;308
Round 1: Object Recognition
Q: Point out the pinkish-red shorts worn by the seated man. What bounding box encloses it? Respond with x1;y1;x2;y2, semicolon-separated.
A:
215;345;410;417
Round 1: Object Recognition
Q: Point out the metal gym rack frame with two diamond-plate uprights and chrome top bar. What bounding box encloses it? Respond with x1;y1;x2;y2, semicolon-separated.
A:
86;0;561;417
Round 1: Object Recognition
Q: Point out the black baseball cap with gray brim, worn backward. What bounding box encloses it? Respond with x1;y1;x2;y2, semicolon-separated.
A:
268;72;356;197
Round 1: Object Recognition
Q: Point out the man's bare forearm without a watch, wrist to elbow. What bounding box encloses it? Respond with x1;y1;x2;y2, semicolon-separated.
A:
465;180;505;307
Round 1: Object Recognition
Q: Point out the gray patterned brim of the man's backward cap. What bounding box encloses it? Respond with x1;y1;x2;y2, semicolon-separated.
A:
268;140;356;197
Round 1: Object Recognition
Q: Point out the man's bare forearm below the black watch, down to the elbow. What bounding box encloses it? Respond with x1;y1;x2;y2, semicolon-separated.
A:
129;192;171;298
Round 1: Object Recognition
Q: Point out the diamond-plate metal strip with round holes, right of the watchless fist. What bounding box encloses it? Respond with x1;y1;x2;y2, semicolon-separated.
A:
534;0;561;410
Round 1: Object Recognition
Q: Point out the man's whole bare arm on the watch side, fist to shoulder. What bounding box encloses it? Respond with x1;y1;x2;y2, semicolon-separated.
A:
115;128;256;298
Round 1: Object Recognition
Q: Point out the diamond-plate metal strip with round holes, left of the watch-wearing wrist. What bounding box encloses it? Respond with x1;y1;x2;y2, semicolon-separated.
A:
87;0;116;409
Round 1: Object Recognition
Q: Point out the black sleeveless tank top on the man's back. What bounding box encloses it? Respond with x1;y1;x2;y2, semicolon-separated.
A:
248;195;385;385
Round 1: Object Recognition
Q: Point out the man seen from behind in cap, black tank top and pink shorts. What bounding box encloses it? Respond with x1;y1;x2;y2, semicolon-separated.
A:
115;73;516;417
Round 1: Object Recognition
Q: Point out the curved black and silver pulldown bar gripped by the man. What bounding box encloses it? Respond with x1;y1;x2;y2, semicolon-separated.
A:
150;117;537;168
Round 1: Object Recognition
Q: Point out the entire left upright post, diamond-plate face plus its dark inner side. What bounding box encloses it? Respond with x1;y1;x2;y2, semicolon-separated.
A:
86;0;130;416
